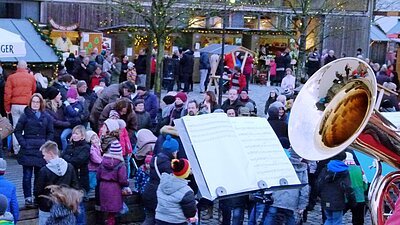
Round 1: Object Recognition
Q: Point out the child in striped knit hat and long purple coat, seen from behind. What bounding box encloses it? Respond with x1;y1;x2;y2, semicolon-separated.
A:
97;140;130;225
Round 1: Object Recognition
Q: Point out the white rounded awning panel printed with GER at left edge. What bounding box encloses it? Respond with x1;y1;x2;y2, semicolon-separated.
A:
0;28;26;58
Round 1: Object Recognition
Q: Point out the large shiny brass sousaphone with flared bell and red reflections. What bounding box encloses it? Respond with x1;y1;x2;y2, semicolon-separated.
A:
289;58;400;225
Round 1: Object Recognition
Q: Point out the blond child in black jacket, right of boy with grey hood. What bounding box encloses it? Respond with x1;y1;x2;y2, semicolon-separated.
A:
61;125;90;192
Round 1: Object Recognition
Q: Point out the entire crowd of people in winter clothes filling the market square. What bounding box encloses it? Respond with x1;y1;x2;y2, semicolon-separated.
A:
0;43;398;225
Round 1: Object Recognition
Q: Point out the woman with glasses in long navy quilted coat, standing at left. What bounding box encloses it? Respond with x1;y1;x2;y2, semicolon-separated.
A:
14;93;54;207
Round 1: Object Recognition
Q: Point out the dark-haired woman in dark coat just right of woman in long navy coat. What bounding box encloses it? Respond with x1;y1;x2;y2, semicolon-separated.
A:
46;87;71;146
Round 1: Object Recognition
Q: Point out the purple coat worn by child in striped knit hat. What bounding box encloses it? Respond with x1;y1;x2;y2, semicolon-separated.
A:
97;155;129;213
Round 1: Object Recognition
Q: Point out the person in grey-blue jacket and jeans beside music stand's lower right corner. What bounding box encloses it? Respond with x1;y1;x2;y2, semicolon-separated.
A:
264;148;310;225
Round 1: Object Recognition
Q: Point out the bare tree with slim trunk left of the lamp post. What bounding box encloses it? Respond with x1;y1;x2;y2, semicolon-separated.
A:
113;0;219;98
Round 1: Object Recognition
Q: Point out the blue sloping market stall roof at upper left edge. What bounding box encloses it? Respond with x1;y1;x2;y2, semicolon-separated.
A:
0;19;58;63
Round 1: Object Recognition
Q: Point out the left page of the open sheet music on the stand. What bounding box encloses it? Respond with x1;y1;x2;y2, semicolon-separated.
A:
182;113;254;198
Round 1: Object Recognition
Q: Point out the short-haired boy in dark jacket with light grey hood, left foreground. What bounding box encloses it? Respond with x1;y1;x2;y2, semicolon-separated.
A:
37;141;80;225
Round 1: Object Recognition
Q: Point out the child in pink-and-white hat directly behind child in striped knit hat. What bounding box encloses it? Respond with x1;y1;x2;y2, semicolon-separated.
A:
99;110;132;174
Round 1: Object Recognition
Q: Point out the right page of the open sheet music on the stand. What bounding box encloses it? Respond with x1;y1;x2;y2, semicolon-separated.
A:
229;117;300;187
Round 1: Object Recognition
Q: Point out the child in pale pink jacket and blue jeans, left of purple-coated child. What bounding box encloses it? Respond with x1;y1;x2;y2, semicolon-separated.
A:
86;130;103;192
